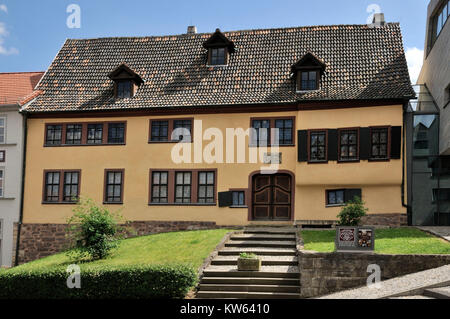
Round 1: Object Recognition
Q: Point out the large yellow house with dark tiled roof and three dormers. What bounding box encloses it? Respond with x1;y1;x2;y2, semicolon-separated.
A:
20;21;415;261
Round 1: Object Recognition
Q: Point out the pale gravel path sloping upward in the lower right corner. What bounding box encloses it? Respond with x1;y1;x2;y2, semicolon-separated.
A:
319;265;450;299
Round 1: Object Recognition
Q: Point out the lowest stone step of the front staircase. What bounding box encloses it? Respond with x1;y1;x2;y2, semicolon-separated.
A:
197;291;300;299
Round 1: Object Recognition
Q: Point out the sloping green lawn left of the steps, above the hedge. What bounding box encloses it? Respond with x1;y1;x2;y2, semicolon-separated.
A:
11;229;231;271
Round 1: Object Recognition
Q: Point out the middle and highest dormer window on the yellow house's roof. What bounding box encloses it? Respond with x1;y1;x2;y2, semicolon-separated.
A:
203;29;234;66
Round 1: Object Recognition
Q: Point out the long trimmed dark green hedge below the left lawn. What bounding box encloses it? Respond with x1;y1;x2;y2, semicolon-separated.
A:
0;265;197;299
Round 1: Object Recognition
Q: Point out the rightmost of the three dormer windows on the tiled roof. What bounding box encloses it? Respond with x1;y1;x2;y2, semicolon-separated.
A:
292;53;325;92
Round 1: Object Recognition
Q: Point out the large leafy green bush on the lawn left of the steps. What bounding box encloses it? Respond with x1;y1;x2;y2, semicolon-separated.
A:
67;199;123;259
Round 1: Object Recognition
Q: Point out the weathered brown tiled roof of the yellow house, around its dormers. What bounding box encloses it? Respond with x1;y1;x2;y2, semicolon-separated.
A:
28;23;414;112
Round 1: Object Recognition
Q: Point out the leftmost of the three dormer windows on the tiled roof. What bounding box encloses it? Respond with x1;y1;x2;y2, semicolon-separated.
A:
109;63;144;99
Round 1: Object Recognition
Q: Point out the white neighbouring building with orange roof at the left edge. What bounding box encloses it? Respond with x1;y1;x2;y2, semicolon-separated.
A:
0;72;43;267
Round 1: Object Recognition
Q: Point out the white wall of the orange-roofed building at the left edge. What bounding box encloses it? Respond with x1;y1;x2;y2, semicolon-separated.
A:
0;105;23;267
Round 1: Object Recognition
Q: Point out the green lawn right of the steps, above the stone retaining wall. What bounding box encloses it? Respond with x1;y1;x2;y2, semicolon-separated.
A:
301;228;450;254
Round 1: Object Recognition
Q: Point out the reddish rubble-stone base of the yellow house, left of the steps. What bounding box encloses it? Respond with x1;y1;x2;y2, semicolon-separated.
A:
19;221;219;264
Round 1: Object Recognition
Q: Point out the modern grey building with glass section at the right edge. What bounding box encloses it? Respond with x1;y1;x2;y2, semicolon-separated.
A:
410;0;450;226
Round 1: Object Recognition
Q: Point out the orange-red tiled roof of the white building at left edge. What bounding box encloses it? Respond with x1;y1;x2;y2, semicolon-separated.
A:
0;72;44;105
